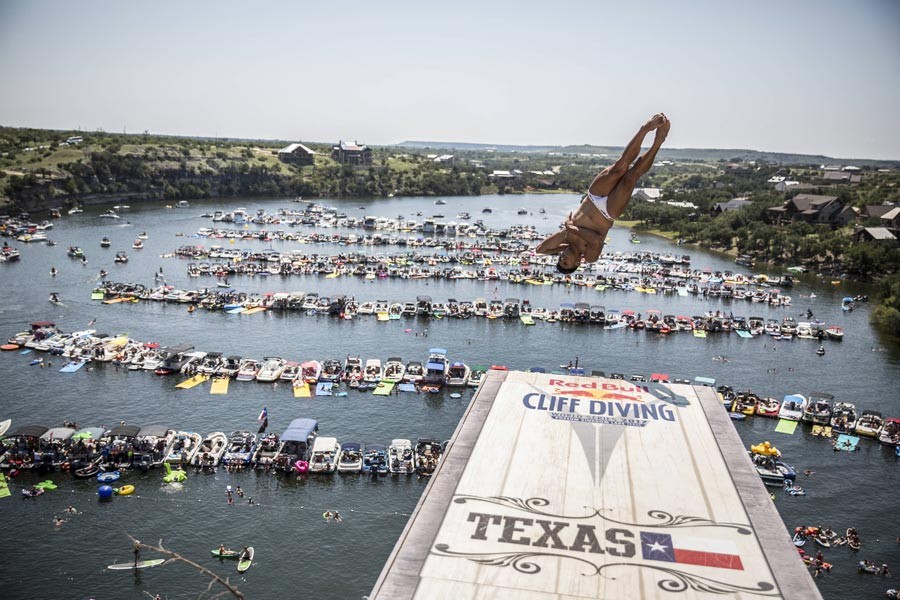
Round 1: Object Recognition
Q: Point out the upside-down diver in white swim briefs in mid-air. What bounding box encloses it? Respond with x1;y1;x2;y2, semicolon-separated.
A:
535;113;670;274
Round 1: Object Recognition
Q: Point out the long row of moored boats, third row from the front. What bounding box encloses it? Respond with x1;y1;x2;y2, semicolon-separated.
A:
91;281;844;341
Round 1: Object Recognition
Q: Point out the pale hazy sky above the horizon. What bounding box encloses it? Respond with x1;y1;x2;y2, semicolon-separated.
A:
0;0;900;159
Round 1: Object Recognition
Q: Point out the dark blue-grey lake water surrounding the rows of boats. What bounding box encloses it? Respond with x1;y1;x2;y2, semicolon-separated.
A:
0;195;900;600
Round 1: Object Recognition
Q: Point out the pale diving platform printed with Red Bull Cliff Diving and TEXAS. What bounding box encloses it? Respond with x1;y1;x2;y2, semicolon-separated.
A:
369;370;821;600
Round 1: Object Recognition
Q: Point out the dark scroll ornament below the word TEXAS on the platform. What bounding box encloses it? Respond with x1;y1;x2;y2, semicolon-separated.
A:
431;544;781;596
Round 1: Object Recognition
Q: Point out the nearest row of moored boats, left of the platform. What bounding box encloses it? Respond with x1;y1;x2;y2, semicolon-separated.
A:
0;418;447;483
